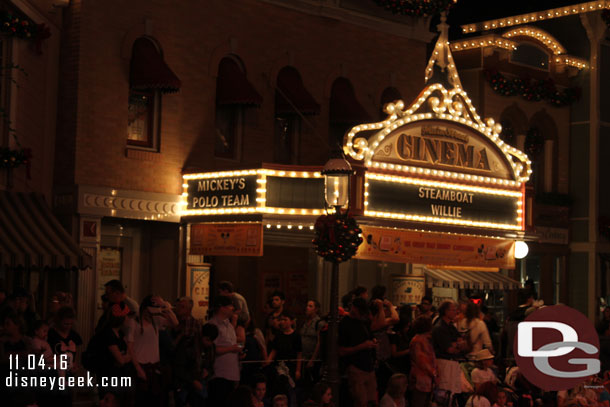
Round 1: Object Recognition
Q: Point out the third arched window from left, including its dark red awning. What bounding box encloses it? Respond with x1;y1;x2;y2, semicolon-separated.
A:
273;66;320;164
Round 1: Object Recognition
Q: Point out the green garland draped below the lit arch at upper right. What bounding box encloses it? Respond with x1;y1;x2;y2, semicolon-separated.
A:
485;70;580;107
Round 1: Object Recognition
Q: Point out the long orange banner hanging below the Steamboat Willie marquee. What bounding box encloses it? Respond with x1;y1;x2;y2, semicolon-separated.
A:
354;226;515;269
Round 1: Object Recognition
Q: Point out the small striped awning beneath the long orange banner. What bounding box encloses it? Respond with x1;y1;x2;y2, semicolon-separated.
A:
424;267;521;290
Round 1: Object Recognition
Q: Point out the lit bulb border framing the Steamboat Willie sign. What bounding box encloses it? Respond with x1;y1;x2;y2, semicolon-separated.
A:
364;173;525;231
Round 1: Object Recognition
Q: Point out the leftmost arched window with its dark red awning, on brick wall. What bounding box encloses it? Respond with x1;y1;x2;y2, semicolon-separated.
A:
127;37;181;151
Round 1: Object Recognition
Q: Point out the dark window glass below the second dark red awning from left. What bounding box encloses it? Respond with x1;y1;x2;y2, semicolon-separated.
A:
214;105;244;160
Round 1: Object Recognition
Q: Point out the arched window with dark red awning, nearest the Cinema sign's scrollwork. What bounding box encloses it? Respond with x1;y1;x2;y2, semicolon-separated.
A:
328;78;371;148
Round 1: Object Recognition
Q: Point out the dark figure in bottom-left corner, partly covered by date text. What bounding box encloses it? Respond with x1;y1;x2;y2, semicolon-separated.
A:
0;307;35;406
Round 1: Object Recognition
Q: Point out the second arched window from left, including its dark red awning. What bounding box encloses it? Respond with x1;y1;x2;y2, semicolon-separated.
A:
214;55;263;161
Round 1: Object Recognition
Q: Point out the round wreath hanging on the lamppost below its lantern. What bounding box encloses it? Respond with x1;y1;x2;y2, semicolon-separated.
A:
313;213;362;263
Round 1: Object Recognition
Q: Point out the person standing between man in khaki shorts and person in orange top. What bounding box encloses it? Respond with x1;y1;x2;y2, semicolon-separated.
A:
371;285;399;393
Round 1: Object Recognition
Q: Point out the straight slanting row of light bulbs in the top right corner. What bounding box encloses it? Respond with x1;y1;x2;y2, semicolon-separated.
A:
462;0;610;33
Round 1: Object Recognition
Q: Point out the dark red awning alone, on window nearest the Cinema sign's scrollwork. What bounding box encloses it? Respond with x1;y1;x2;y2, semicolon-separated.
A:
329;78;371;124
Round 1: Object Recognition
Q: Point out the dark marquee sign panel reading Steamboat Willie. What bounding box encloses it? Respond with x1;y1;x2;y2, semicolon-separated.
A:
367;178;522;229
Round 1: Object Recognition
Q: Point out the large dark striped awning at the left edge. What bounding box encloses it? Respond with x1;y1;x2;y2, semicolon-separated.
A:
0;191;91;268
